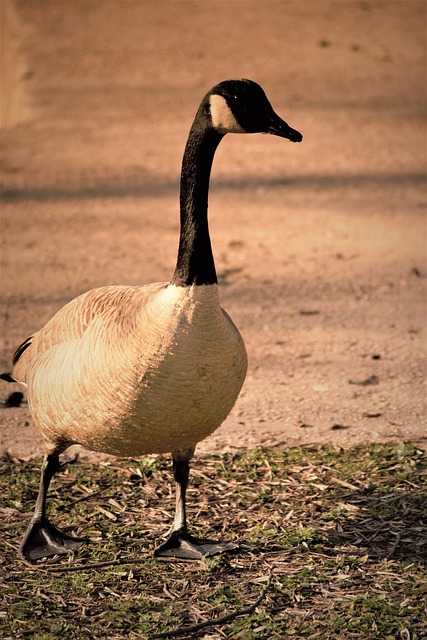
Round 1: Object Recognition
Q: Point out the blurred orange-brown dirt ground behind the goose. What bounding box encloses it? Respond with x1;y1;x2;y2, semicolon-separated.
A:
0;0;427;457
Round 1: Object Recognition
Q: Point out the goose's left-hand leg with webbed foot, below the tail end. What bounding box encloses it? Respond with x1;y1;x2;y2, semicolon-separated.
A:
19;454;85;562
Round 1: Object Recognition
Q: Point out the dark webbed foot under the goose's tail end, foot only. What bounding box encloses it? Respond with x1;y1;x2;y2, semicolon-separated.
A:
19;519;86;562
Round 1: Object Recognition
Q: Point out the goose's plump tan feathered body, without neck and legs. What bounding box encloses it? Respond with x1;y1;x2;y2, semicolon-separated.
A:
13;283;247;455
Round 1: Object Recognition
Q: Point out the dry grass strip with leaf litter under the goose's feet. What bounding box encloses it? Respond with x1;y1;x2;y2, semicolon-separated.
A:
0;444;427;640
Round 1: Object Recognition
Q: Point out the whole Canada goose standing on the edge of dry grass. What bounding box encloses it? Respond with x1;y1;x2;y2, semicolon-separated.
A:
3;79;302;562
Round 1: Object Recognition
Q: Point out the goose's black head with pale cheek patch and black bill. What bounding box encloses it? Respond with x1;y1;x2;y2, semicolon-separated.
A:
206;79;302;142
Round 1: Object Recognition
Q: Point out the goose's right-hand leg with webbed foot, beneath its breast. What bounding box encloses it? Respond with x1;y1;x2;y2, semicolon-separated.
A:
154;457;238;560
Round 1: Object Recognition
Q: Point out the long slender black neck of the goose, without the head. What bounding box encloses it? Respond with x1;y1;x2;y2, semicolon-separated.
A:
172;106;223;286
